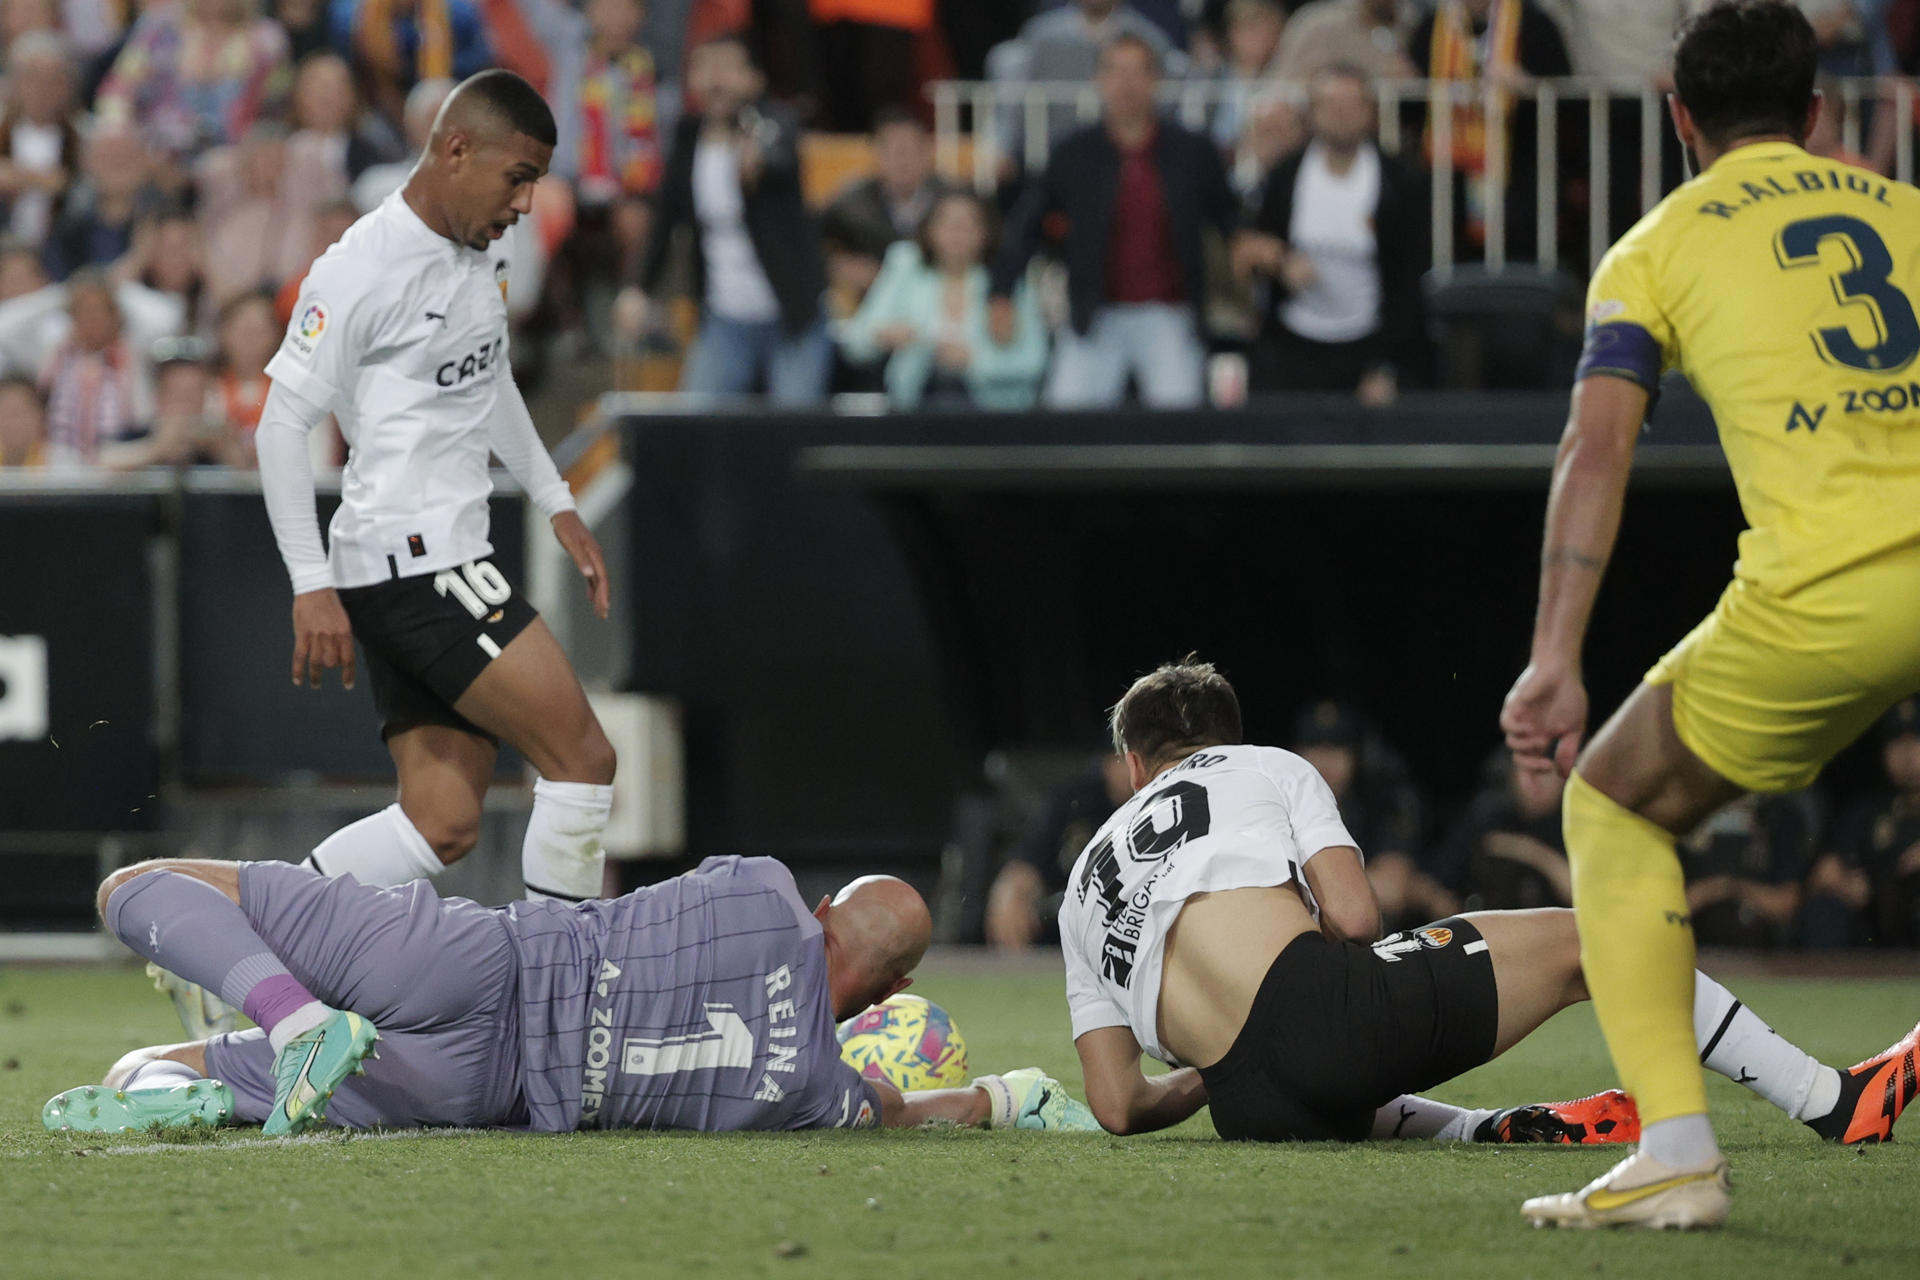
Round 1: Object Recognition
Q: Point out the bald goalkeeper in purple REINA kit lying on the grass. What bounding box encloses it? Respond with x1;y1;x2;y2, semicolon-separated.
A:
42;858;1096;1134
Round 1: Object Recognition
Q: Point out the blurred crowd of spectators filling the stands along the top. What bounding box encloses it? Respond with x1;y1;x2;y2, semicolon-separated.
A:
0;0;1920;466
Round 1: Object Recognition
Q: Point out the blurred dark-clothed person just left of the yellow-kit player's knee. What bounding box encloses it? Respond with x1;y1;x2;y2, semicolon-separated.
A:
1446;748;1572;912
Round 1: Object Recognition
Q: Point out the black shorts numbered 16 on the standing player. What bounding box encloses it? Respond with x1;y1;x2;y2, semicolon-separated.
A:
340;560;540;739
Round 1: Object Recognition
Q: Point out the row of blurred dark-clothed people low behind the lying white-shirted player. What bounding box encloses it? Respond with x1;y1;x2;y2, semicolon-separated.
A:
985;699;1920;948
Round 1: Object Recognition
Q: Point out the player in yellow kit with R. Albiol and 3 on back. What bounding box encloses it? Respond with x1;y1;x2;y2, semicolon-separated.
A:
1501;0;1920;1228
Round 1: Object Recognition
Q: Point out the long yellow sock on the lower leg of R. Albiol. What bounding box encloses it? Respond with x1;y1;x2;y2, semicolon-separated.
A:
1561;773;1707;1125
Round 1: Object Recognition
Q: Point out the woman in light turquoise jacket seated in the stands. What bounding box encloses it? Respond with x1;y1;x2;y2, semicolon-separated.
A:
841;192;1046;409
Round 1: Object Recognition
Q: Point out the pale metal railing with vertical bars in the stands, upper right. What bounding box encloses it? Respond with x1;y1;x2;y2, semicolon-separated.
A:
927;77;1920;274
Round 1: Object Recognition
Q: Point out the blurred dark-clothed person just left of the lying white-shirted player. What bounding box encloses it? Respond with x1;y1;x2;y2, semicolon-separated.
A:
987;754;1133;950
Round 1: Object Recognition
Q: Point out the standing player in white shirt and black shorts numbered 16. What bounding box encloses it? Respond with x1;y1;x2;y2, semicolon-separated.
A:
259;71;614;900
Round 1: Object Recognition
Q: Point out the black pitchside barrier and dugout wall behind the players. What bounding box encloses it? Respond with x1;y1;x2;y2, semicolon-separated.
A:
0;388;1904;948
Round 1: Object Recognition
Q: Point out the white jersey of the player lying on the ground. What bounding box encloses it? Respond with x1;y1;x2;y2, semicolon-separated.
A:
1060;747;1354;1065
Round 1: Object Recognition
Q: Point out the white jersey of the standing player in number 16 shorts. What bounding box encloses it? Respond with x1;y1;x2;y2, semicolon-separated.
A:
267;192;564;587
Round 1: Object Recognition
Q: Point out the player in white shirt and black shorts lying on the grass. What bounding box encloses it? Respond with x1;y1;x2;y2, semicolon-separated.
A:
1060;662;1916;1142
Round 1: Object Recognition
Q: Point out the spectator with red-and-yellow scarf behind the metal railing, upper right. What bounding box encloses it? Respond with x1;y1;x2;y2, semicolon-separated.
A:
1411;0;1572;263
